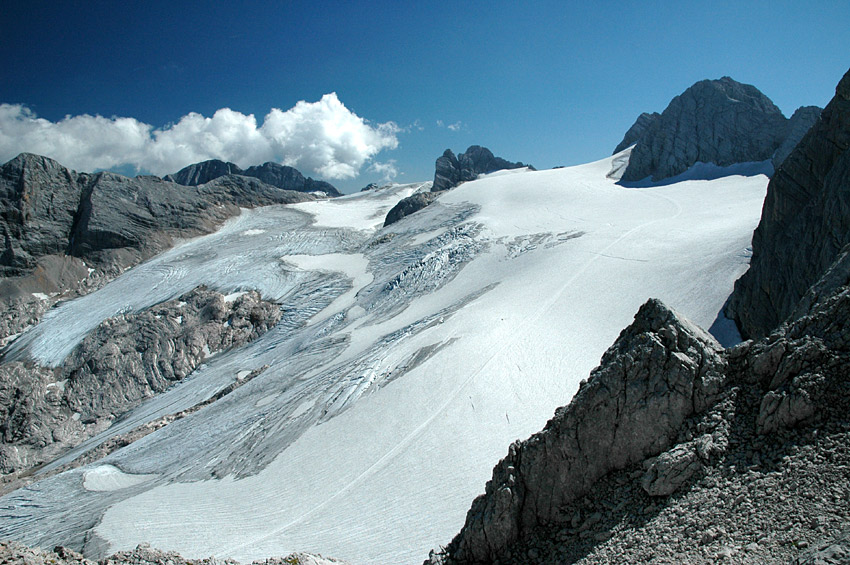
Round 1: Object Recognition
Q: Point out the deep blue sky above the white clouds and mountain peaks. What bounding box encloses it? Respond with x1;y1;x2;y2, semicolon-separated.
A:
0;0;850;191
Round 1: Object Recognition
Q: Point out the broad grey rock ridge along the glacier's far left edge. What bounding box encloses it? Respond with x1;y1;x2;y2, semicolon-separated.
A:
0;153;314;340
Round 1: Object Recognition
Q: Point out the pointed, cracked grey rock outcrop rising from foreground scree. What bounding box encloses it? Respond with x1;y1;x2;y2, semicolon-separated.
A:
438;300;725;563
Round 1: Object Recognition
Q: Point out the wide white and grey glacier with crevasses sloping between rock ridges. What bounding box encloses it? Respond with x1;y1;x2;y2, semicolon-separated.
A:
0;154;768;564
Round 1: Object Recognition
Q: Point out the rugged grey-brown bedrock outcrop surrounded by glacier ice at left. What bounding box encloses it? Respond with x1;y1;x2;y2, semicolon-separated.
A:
0;287;281;474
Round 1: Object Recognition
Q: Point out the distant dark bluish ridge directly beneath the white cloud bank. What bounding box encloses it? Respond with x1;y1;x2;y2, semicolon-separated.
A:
163;159;342;196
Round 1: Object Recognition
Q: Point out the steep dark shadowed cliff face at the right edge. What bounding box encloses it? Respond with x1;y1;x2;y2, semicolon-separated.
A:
727;67;850;337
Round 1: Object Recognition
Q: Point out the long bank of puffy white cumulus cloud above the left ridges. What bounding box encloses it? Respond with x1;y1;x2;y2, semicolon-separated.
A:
0;93;402;179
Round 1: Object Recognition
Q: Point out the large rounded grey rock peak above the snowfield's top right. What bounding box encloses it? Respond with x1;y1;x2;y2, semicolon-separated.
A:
614;77;818;182
